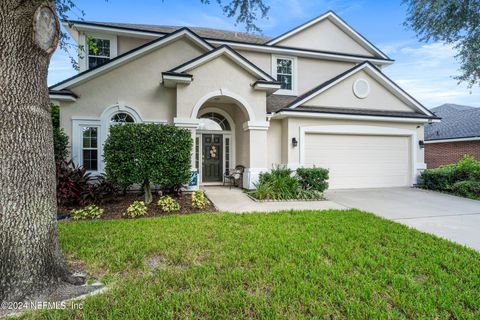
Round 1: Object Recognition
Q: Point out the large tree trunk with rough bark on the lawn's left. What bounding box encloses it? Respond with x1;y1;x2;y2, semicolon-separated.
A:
0;0;68;301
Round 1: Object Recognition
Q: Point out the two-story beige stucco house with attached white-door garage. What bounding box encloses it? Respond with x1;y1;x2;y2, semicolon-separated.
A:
50;11;436;188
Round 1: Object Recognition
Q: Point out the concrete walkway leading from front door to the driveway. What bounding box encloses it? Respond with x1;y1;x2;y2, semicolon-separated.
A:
202;186;346;213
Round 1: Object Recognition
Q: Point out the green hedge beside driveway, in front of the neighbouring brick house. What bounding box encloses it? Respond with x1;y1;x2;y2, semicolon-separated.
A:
420;155;480;199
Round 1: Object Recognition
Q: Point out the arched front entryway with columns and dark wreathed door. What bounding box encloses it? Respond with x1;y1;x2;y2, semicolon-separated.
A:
180;89;269;189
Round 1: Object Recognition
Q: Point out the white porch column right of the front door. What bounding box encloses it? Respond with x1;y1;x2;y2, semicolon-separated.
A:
243;121;269;189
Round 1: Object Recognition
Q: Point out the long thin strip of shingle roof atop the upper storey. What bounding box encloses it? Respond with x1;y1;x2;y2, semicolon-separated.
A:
75;21;271;44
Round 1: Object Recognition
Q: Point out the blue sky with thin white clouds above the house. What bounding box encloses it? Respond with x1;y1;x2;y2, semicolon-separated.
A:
48;0;480;108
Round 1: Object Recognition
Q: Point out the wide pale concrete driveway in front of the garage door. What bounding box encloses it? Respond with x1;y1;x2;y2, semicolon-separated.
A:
326;188;480;250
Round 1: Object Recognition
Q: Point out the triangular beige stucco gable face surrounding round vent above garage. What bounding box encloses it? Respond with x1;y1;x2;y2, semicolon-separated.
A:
303;71;415;112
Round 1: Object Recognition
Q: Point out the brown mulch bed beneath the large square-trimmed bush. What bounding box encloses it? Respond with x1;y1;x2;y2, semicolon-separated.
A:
58;192;217;219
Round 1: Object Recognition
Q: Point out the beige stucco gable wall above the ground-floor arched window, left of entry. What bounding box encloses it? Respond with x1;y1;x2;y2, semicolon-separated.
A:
60;39;204;141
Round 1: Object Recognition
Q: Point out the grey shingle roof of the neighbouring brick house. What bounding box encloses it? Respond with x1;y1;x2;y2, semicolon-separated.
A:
425;104;480;141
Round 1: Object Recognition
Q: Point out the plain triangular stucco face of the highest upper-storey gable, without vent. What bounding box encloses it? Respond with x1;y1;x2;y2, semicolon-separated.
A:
276;19;373;56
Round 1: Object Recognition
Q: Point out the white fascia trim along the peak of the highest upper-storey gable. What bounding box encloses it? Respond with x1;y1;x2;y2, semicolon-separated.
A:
267;11;388;59
